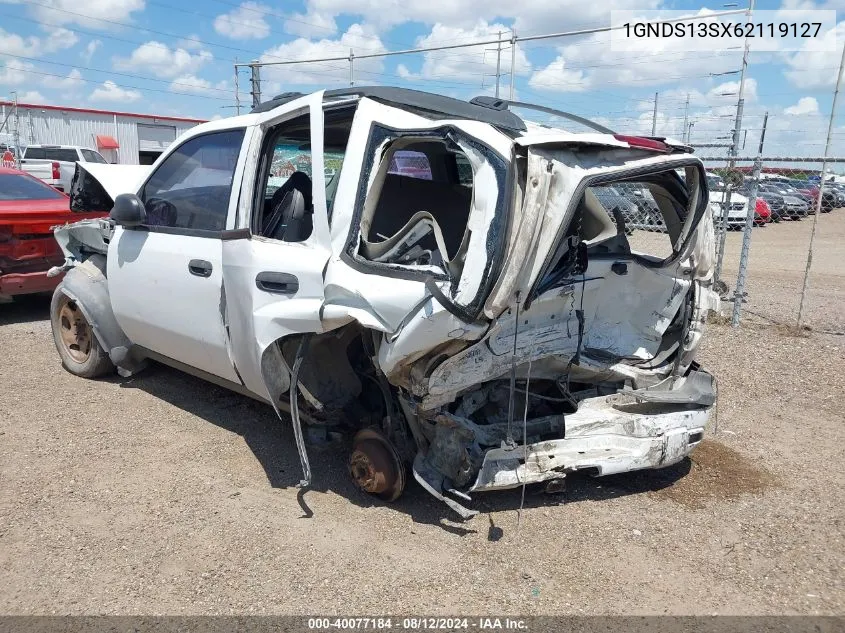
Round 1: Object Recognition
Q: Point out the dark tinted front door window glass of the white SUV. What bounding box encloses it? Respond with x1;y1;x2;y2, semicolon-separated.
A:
141;129;244;231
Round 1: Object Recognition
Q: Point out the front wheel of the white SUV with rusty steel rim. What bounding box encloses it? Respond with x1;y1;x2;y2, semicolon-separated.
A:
50;288;114;378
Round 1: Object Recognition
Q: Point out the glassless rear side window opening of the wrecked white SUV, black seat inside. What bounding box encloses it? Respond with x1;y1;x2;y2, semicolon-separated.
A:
358;138;473;271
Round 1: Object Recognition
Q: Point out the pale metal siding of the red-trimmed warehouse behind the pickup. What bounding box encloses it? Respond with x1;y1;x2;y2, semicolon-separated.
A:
0;106;197;165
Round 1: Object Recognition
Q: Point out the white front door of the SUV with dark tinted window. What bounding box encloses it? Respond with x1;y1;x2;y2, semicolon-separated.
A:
108;128;246;383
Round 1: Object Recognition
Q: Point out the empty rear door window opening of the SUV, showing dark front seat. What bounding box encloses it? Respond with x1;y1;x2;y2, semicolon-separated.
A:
252;106;355;242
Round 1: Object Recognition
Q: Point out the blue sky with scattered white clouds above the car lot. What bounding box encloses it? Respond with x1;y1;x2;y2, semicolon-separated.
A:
0;0;845;155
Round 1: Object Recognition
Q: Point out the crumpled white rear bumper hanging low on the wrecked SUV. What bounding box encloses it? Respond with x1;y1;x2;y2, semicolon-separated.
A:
471;393;714;491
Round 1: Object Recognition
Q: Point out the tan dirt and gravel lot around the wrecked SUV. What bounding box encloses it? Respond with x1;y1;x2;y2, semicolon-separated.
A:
0;210;845;615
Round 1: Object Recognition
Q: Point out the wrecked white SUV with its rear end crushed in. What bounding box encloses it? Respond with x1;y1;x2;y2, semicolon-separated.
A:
52;88;718;517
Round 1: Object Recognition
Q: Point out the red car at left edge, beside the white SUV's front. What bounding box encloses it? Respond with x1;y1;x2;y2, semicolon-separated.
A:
0;167;106;299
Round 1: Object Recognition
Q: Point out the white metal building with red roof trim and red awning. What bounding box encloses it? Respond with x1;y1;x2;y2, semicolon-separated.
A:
0;101;205;165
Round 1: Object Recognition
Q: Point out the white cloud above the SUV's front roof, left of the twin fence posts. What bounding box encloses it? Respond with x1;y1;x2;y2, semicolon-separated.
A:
261;24;387;87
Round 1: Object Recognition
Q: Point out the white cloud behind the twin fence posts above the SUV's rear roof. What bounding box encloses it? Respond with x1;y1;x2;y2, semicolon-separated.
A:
397;20;531;88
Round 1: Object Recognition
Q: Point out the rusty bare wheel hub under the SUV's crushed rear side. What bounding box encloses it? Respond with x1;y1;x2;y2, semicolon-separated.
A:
349;429;405;501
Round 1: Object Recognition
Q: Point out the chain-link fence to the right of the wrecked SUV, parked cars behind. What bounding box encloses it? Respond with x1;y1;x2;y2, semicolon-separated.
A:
705;157;845;331
